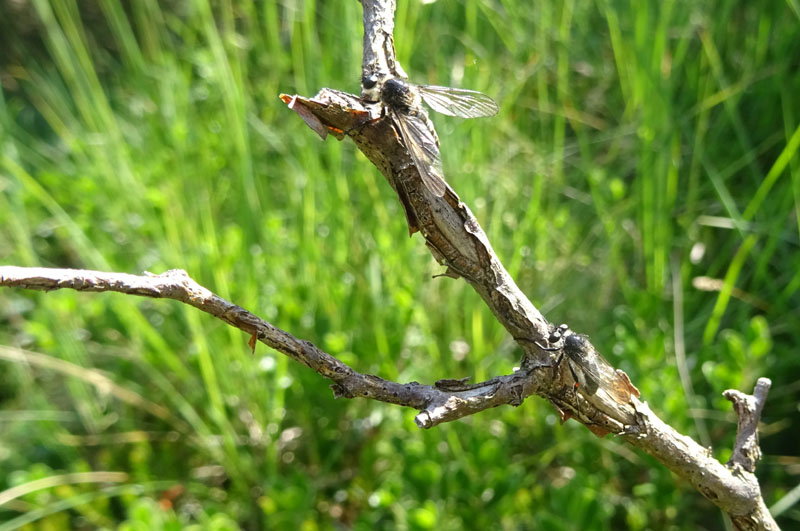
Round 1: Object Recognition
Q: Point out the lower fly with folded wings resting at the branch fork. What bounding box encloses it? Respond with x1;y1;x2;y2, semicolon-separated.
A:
539;324;639;404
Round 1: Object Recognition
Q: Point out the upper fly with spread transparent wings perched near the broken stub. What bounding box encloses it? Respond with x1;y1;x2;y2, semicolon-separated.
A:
361;74;498;197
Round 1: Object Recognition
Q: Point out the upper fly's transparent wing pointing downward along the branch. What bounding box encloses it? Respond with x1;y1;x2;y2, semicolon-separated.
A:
391;111;447;197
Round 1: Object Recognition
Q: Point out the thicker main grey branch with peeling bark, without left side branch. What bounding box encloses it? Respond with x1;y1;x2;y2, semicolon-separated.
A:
281;0;777;529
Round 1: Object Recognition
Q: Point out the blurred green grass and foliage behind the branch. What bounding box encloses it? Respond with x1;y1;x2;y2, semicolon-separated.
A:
0;0;800;530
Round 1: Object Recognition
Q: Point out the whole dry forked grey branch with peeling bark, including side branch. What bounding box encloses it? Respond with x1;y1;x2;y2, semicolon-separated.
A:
0;0;777;529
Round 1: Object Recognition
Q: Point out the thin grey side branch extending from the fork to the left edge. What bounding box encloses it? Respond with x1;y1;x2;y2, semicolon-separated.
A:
0;266;549;428
